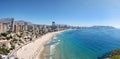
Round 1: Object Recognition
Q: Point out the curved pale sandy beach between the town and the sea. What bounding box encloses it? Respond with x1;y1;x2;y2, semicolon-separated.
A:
17;30;64;59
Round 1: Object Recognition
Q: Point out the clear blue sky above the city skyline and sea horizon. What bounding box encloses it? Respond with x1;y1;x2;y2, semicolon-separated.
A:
0;0;120;28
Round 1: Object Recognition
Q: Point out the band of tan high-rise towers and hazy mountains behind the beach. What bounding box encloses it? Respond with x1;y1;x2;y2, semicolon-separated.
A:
0;18;71;33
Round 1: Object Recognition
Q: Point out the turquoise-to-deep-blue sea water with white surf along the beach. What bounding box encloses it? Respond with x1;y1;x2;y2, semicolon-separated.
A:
50;29;120;59
